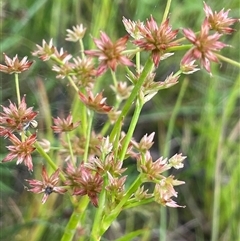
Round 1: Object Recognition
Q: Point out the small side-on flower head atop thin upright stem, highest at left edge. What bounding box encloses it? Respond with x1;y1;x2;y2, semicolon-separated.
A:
0;53;33;74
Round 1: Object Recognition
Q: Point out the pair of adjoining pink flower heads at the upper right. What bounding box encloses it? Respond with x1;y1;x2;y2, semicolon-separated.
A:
181;2;238;73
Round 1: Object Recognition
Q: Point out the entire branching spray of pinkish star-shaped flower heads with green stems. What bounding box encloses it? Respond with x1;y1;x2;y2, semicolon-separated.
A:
0;3;238;239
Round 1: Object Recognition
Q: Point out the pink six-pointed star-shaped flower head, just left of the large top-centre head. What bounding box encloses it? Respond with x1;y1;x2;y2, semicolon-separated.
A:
85;32;133;75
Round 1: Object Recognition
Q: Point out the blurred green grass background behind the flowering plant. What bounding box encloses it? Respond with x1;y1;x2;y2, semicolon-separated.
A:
0;0;240;241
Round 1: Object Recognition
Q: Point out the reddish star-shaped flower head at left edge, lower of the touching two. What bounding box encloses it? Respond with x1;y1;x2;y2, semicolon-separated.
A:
2;133;36;171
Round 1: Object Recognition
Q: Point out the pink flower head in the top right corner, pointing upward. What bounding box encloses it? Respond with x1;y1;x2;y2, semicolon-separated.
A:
203;2;239;34
